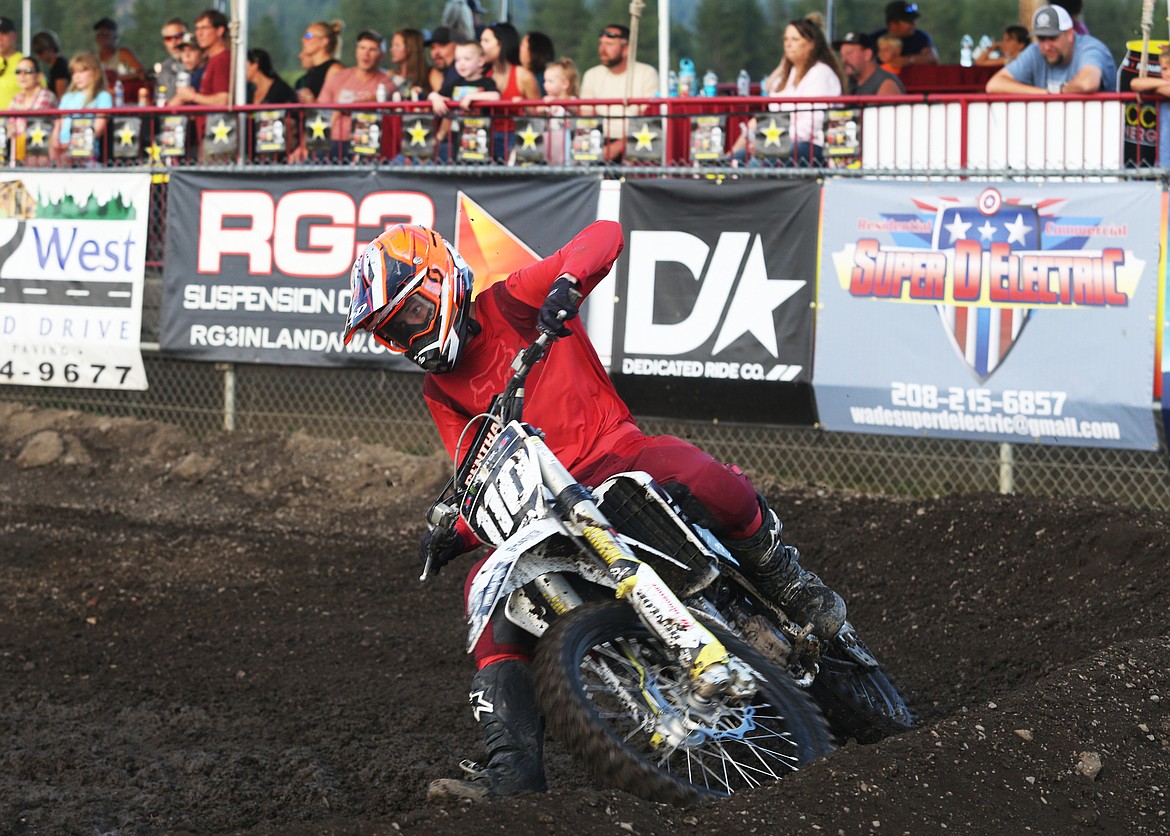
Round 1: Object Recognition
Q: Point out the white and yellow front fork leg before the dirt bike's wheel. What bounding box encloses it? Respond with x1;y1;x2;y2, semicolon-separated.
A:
529;438;756;698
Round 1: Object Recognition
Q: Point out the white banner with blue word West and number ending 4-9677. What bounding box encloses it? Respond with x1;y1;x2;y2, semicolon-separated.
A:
0;172;150;389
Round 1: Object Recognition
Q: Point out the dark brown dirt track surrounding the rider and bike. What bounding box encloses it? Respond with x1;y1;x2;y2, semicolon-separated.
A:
0;402;1170;836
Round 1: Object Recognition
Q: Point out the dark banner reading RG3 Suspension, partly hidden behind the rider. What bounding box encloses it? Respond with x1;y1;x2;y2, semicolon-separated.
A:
160;172;599;371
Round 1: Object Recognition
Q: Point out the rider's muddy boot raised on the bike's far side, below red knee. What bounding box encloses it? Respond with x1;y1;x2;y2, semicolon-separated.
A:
723;497;845;638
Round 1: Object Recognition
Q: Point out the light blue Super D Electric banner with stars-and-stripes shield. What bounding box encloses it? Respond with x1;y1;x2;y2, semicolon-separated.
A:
813;181;1164;449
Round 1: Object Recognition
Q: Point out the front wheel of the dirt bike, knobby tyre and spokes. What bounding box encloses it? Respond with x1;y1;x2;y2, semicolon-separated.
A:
534;601;833;804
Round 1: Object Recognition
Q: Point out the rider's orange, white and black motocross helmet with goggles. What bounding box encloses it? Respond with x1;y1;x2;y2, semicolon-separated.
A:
345;223;473;372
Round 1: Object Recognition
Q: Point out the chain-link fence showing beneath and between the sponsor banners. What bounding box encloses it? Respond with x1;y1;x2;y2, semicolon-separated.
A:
0;172;1170;510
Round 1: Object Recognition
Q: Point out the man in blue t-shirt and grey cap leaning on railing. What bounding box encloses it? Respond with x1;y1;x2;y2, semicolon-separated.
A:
986;6;1117;96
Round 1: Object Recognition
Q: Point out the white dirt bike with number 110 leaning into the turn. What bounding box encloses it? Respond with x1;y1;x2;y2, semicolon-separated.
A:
421;334;913;803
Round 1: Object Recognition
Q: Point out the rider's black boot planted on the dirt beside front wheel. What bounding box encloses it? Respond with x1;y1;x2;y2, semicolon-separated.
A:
427;659;548;802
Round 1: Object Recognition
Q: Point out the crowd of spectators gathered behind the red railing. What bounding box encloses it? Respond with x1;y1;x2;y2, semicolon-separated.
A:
0;0;1161;165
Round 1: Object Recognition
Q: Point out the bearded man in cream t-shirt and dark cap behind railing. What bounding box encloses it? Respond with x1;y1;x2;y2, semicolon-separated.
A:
581;23;659;163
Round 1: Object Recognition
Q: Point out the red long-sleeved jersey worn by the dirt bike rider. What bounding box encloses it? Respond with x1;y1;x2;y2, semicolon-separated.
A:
422;221;636;471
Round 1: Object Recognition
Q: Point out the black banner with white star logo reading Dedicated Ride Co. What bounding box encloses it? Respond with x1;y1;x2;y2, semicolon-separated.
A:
613;180;820;423
